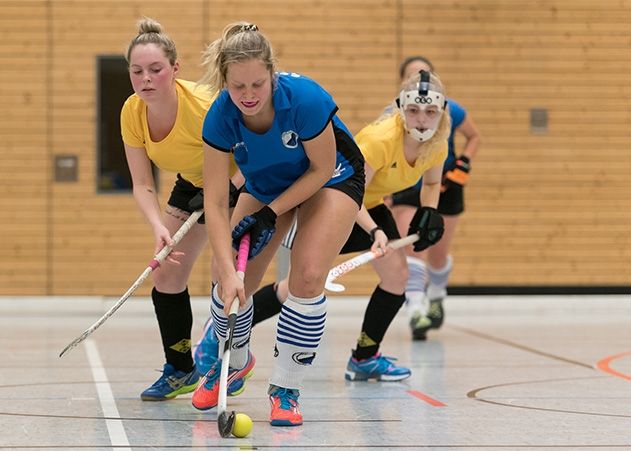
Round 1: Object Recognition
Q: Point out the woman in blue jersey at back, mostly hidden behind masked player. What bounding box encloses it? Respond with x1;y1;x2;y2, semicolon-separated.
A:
388;56;480;340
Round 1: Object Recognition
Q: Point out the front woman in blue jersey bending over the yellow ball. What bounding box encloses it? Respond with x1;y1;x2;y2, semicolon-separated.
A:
193;22;364;426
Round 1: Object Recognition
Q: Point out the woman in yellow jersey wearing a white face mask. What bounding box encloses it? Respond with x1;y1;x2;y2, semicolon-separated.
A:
253;71;451;381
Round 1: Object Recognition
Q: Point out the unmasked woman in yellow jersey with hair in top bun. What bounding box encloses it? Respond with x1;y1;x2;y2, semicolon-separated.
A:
121;18;241;401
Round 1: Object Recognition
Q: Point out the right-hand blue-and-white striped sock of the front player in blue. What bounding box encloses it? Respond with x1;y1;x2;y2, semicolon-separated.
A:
270;293;326;389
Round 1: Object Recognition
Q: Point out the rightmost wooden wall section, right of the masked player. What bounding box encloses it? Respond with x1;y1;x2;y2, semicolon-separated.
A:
402;0;631;286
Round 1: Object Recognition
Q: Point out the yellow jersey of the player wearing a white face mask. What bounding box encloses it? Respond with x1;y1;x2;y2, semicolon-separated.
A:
355;114;448;209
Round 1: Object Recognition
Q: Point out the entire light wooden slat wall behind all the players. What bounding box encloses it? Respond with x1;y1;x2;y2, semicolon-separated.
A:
0;0;631;296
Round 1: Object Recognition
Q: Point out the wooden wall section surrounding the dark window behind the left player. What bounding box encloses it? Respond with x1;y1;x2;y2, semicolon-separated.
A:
52;0;209;296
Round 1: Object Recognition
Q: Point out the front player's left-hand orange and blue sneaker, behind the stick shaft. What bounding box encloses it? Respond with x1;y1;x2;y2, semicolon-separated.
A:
192;351;256;410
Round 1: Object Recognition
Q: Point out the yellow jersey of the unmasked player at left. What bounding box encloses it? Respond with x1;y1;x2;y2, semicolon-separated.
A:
121;79;236;188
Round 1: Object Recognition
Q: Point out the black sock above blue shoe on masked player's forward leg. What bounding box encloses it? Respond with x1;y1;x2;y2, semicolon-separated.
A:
353;286;405;360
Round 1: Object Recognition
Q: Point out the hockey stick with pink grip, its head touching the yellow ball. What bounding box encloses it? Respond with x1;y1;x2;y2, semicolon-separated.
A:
217;233;250;437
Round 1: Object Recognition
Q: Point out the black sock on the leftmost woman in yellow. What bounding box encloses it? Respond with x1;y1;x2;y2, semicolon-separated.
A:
151;288;195;372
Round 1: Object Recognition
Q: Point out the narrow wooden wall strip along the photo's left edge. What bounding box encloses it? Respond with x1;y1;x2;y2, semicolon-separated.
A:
0;1;51;295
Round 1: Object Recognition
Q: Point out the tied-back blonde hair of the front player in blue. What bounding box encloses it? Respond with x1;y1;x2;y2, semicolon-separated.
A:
198;22;276;92
